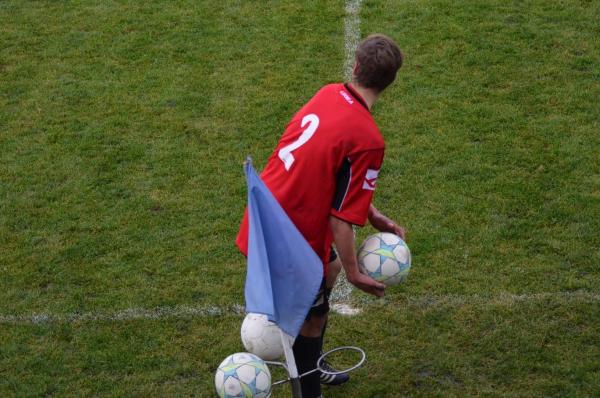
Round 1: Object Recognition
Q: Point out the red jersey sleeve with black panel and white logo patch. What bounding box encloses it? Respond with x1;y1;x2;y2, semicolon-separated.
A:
331;149;383;226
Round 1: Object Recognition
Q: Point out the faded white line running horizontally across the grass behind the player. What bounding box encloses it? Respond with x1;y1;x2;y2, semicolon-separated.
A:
0;291;600;325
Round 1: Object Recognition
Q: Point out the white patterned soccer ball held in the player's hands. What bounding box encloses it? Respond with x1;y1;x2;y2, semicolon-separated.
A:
357;232;410;286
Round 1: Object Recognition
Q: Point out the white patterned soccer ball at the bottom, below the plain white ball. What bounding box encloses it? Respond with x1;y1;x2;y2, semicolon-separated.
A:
215;352;271;398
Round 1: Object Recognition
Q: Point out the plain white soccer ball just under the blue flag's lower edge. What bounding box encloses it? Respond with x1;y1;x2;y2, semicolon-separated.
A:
241;313;283;361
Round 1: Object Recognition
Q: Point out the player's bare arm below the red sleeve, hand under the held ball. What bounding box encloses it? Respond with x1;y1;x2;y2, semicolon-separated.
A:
329;216;385;297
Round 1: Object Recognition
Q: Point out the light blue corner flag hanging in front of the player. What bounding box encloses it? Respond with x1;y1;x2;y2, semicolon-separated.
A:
244;158;323;338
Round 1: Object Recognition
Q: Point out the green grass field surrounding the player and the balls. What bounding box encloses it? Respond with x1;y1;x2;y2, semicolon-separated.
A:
0;0;600;397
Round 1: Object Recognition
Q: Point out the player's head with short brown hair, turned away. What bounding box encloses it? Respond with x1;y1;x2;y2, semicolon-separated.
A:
352;34;403;92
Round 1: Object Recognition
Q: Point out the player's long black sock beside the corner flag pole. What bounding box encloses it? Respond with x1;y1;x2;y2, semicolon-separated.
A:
292;335;322;398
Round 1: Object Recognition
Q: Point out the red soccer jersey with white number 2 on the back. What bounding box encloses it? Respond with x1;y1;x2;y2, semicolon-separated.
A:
236;84;384;264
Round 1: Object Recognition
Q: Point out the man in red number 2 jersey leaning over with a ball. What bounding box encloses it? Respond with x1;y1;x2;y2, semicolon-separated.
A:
236;35;404;398
